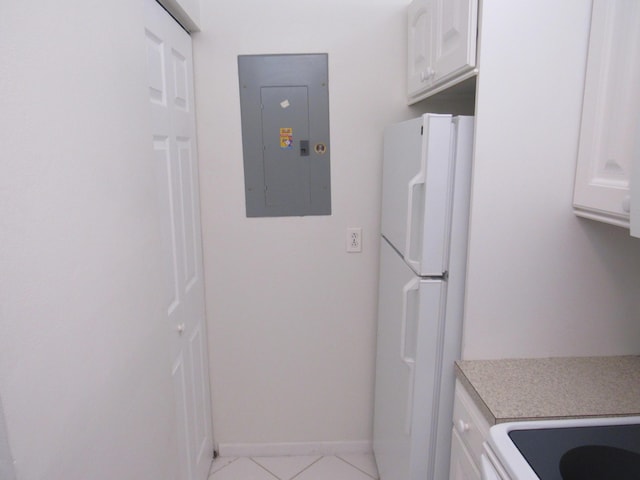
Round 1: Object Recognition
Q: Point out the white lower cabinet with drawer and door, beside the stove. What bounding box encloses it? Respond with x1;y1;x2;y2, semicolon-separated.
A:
449;381;490;480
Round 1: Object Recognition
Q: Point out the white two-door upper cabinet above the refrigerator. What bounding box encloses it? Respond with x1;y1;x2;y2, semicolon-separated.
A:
407;0;478;104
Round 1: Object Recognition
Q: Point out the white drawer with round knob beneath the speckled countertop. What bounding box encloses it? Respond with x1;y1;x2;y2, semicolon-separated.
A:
453;381;489;465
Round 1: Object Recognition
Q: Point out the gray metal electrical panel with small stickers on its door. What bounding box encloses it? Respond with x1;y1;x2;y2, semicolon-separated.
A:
238;54;331;217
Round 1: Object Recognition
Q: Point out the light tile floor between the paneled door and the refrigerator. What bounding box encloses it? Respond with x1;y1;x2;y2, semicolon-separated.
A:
209;454;378;480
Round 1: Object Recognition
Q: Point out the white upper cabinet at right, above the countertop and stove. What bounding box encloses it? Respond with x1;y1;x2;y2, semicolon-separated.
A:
573;0;640;233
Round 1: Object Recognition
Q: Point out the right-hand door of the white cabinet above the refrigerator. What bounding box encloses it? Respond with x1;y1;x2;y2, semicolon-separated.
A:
433;0;478;83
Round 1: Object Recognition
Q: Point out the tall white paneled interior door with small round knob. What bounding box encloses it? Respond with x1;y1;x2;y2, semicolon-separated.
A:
145;0;213;480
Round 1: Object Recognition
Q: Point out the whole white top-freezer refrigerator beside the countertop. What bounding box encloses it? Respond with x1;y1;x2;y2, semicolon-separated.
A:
373;114;474;480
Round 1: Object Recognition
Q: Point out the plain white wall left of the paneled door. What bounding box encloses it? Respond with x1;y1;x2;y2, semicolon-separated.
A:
0;0;177;480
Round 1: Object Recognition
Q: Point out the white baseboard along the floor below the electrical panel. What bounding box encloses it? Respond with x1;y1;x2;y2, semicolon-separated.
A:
218;440;372;457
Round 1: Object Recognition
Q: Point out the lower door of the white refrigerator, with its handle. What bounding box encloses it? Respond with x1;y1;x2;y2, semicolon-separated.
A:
373;239;451;480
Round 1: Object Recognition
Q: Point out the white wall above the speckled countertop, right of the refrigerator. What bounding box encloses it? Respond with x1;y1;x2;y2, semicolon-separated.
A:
463;0;640;359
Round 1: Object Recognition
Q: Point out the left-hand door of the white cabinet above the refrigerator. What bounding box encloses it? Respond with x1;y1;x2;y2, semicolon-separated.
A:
407;0;435;96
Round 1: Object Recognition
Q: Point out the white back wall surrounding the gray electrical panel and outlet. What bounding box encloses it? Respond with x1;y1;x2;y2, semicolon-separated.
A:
194;0;409;444
